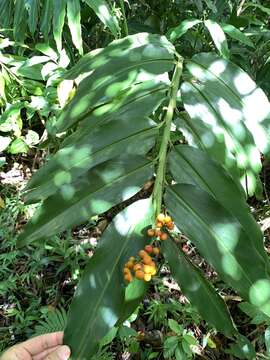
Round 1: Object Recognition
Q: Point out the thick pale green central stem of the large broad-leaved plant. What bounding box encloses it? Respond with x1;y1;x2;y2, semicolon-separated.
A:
153;58;183;216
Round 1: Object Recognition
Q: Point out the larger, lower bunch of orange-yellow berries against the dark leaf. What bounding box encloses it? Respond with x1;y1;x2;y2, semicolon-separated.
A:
124;245;160;282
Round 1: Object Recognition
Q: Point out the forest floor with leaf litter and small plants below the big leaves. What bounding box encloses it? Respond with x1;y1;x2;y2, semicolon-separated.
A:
0;153;270;360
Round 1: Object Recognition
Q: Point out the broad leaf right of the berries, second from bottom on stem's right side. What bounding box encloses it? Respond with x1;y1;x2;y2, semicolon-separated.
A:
165;184;270;316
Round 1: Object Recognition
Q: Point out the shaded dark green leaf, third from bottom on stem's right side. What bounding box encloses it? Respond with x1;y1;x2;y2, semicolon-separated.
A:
169;145;270;262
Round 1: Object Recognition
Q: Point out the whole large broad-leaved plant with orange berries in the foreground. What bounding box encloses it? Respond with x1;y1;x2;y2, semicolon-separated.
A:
10;0;270;360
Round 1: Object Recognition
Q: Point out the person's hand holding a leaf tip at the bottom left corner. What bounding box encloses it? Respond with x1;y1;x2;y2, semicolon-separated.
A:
0;332;70;360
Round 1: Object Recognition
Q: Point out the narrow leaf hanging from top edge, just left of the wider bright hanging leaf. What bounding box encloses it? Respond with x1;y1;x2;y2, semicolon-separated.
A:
53;0;66;53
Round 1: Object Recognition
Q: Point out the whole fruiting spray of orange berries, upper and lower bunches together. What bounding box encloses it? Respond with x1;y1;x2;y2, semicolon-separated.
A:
123;214;174;282
